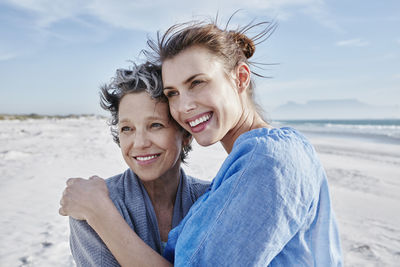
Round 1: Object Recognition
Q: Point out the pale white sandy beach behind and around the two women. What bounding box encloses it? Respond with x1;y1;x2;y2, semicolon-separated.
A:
0;117;400;266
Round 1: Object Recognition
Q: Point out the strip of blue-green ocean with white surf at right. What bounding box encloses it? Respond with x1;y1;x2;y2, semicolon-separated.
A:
272;119;400;144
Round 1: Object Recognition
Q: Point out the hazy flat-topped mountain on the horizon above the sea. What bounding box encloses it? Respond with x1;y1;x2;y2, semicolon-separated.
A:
271;99;400;119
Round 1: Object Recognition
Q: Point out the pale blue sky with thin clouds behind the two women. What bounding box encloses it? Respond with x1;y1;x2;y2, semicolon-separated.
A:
0;0;400;114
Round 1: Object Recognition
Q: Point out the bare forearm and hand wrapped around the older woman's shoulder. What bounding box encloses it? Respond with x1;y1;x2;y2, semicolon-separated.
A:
59;177;171;266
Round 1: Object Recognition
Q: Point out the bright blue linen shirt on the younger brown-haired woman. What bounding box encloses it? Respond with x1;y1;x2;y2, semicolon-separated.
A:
164;128;342;267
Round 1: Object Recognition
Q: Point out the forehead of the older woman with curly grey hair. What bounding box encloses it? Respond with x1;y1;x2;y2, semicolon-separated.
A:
118;91;169;120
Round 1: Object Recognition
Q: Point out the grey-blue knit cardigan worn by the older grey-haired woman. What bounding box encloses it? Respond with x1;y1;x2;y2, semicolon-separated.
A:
69;169;209;267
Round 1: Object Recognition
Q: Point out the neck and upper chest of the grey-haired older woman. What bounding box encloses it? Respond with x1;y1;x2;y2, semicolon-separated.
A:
142;161;181;209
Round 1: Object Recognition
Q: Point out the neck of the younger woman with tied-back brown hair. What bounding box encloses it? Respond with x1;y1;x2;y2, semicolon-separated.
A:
221;108;270;154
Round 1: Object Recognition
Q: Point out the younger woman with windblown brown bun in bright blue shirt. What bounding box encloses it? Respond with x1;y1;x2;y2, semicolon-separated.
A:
153;24;342;266
